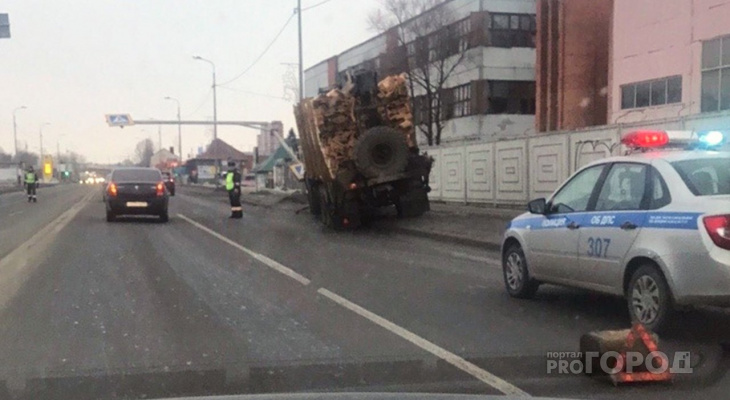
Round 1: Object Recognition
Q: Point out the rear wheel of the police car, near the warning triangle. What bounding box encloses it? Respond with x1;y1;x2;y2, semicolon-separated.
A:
627;265;672;332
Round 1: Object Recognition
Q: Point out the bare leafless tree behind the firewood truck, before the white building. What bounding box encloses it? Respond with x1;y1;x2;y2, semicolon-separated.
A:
368;0;469;146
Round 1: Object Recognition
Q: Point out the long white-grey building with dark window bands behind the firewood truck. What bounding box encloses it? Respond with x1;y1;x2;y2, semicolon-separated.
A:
305;0;536;145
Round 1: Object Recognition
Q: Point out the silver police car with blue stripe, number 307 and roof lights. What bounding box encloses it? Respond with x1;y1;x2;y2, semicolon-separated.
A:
502;131;730;331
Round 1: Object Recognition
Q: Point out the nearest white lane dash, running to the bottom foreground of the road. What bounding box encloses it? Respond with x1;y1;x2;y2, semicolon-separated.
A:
317;288;530;397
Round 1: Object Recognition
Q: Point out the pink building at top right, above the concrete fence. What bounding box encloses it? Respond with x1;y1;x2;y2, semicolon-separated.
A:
609;0;730;123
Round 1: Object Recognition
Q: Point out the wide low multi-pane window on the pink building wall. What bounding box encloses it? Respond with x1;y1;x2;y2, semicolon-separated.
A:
621;76;682;110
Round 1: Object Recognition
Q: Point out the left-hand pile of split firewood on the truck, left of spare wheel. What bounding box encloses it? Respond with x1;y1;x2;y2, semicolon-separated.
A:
313;89;359;174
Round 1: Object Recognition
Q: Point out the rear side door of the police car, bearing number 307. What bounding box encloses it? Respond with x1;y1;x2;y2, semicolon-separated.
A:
574;163;651;292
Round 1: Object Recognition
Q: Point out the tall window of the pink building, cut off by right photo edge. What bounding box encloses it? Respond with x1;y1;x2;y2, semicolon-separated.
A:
701;36;730;112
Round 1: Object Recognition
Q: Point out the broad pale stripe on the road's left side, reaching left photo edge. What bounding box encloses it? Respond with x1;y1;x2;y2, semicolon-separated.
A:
0;193;93;309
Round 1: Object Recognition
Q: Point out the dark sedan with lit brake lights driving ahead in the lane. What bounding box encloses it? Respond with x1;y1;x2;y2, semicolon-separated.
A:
106;168;170;222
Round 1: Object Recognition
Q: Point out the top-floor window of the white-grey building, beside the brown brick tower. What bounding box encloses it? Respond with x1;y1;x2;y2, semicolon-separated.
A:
487;13;537;47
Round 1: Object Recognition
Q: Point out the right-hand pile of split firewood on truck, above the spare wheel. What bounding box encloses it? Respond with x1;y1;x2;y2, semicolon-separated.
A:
378;74;416;147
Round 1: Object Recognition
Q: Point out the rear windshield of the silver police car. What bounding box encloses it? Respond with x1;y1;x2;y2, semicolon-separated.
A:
672;158;730;196
